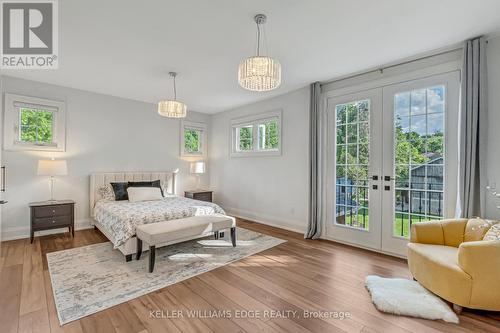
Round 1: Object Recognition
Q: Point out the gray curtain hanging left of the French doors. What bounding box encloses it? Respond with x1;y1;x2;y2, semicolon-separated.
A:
305;82;322;239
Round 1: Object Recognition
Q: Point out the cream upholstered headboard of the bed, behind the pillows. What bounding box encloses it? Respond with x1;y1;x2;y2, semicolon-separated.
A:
90;169;179;217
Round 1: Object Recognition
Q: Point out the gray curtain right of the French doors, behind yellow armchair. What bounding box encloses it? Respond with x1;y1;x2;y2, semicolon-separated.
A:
456;37;488;217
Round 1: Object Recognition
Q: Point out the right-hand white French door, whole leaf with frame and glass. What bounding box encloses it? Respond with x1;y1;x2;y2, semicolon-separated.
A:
382;72;459;255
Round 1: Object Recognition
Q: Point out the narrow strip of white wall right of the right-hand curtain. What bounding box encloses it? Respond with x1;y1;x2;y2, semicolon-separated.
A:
486;37;500;220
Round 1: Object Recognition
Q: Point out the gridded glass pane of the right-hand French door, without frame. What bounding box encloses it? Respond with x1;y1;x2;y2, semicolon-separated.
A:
393;85;446;238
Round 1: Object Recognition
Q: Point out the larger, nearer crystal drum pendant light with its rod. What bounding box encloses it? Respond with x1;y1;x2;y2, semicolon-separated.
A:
238;14;281;91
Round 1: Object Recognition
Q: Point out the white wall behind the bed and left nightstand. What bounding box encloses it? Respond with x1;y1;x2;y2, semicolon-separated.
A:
1;77;210;240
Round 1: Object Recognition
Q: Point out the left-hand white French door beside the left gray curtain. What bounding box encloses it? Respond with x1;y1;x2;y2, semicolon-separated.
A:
326;89;382;249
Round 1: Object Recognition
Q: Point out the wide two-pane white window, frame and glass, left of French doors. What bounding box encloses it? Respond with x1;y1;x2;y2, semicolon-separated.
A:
231;110;282;157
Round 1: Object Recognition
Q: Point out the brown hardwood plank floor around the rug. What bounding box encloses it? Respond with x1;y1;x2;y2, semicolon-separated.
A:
0;220;500;333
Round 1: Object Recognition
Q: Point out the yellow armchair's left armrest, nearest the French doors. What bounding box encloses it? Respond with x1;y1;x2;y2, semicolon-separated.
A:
410;219;468;246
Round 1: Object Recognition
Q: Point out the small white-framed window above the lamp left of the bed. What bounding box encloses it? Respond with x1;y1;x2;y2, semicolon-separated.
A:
4;94;66;151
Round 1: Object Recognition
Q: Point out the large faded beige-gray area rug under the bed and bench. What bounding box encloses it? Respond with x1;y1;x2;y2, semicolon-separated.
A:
47;228;285;325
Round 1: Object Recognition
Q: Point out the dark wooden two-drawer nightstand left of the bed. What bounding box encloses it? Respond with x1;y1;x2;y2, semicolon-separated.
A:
29;200;75;243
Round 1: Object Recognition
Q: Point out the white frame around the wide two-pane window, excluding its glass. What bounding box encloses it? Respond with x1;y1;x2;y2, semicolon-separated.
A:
229;109;283;157
